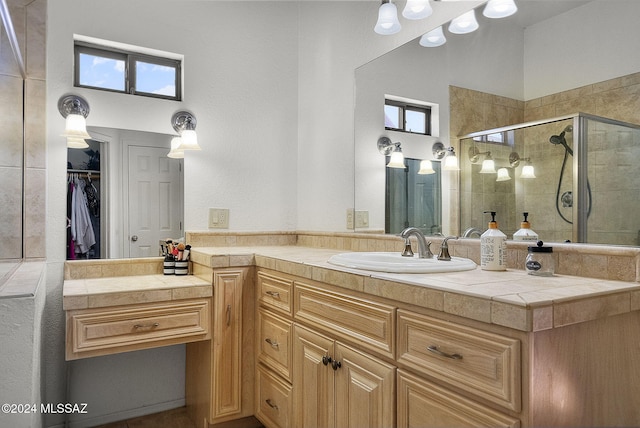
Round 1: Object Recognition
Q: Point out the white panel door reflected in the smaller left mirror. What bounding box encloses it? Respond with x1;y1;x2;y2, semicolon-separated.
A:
128;146;183;257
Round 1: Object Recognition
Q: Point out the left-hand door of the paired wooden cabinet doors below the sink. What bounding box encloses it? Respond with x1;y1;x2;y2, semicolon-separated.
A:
293;325;335;428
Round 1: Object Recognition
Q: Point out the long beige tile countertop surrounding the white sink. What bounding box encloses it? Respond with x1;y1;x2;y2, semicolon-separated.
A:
192;246;640;331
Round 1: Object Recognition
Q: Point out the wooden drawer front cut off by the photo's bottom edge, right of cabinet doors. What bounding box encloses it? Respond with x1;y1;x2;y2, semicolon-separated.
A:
397;370;520;428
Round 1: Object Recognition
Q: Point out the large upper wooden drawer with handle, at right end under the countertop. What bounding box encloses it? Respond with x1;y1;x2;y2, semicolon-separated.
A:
398;310;521;411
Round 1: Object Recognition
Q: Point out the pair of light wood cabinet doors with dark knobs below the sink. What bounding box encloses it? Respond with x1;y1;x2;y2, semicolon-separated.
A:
293;325;396;428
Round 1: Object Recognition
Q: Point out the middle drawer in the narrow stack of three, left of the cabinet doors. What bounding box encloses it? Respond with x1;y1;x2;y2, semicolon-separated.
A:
258;308;292;381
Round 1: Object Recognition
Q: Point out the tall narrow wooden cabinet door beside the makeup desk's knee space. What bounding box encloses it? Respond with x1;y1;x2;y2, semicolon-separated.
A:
211;269;245;419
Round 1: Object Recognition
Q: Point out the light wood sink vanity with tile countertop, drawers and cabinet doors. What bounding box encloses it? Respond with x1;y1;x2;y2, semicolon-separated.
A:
65;240;640;428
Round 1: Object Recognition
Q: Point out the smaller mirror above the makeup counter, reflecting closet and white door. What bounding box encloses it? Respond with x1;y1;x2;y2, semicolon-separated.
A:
67;127;184;260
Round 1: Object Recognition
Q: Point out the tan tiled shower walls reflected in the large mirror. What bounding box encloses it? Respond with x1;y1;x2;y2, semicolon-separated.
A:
449;73;640;245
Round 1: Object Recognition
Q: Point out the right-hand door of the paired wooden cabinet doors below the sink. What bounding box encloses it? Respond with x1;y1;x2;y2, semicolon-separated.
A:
335;342;396;428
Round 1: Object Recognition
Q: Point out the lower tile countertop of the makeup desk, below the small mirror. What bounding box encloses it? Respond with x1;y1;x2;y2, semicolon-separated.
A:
62;275;213;311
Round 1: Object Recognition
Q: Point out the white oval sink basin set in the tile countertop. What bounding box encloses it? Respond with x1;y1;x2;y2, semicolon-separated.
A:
328;252;476;273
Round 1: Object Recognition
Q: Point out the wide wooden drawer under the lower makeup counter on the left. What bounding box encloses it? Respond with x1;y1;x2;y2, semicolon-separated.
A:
66;299;211;360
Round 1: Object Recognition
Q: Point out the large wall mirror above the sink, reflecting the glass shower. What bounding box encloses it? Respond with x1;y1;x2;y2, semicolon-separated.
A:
355;0;640;245
